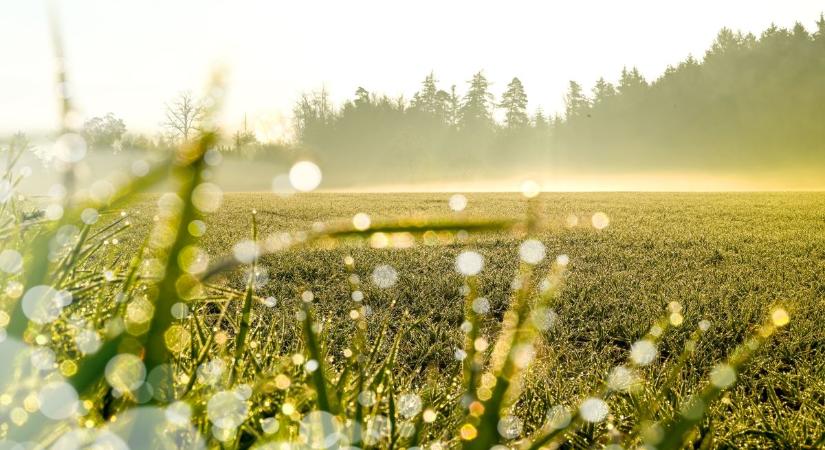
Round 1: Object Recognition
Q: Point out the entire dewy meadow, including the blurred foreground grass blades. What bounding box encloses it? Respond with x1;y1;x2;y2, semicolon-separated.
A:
0;128;825;450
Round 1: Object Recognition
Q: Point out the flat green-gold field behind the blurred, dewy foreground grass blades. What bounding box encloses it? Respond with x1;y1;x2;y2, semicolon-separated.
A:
108;193;825;448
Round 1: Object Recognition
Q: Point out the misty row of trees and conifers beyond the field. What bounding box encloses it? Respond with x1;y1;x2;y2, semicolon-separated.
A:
79;16;825;182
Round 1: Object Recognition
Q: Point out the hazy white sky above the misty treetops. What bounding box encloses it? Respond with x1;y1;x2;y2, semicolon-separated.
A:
0;0;825;133
